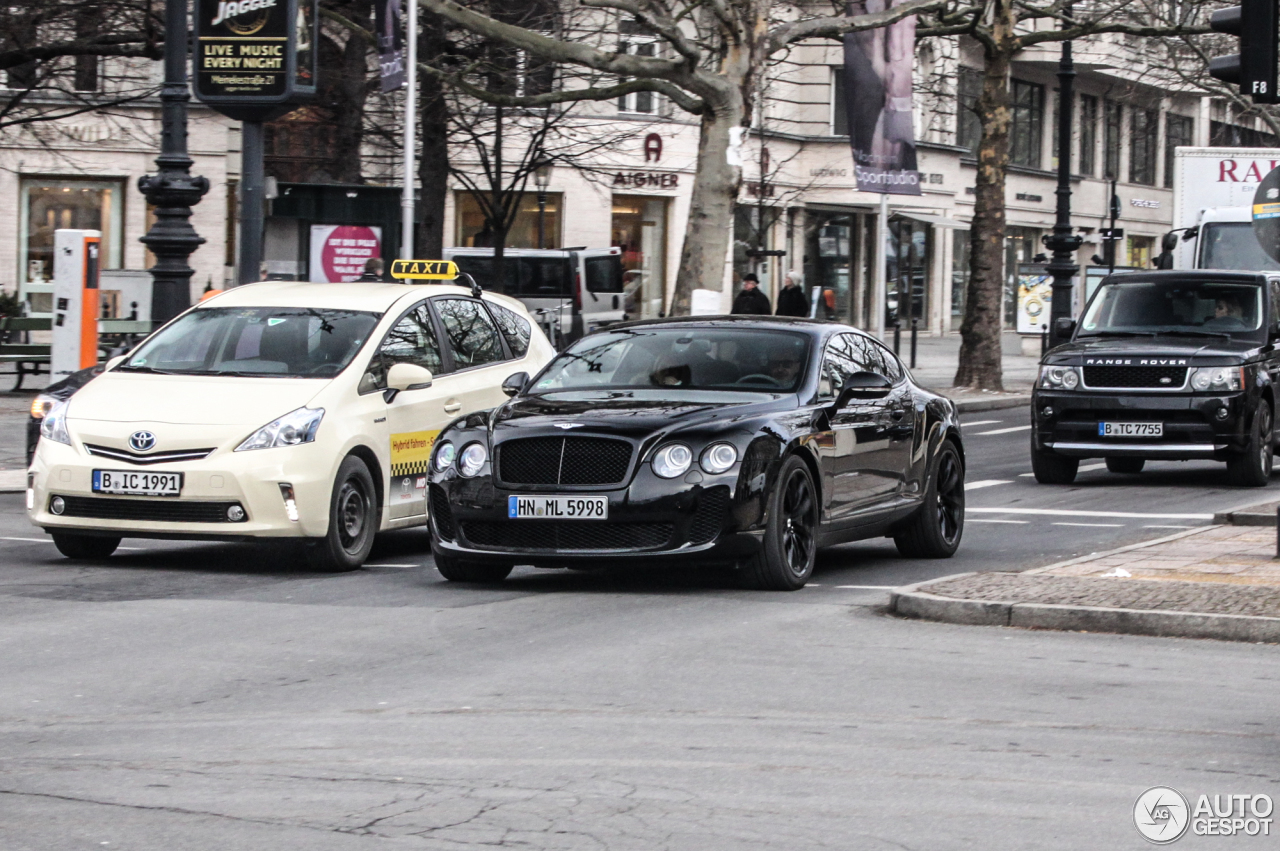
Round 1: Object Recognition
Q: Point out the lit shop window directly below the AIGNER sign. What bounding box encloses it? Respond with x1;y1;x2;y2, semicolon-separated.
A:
611;195;667;319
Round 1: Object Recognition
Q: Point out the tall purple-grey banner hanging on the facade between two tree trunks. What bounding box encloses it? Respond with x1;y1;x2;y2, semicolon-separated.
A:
845;0;922;195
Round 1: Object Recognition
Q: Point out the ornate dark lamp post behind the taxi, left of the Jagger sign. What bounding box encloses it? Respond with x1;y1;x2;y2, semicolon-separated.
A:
138;0;209;321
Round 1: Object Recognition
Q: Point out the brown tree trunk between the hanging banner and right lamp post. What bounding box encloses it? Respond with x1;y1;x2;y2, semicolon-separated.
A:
954;15;1014;390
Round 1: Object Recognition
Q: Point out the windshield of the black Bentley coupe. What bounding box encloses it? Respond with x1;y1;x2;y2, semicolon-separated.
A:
531;328;809;393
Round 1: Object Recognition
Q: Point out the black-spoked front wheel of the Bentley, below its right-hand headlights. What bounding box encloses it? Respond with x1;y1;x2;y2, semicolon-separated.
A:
741;456;818;591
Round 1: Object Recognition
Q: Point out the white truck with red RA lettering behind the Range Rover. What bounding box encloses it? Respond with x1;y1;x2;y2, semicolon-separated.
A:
1160;147;1280;271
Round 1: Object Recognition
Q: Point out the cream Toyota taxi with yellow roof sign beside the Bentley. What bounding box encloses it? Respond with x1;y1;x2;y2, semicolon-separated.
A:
27;268;554;569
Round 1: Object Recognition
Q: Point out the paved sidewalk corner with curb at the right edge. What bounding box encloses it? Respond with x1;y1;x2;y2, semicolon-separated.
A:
890;514;1280;642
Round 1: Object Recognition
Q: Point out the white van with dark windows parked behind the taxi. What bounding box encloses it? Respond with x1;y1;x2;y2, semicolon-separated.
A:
443;248;635;348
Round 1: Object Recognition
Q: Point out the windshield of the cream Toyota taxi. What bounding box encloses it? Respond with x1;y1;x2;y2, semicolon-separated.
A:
116;307;378;379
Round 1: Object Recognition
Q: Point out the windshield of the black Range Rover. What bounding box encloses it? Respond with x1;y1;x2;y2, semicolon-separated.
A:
1078;280;1266;339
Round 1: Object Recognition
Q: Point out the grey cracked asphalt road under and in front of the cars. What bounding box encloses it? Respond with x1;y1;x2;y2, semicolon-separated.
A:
0;412;1280;851
